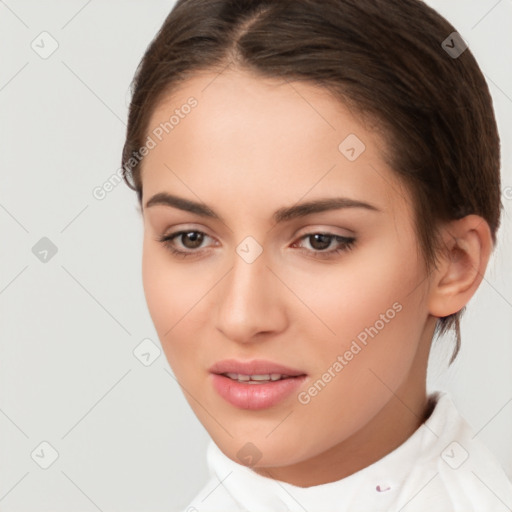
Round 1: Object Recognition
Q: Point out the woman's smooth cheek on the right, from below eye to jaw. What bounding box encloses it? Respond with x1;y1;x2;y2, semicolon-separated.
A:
288;244;426;402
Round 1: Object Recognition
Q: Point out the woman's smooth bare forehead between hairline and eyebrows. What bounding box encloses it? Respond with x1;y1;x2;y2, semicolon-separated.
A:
139;70;406;218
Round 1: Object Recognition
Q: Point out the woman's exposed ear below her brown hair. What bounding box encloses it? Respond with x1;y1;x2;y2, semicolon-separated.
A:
429;215;492;317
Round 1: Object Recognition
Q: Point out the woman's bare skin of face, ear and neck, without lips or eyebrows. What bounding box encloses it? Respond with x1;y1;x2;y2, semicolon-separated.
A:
136;69;491;487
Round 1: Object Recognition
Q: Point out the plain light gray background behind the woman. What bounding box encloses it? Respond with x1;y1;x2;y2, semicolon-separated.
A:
0;0;512;512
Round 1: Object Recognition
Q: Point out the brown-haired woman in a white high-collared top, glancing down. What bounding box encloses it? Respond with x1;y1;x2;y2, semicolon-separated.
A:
119;0;512;512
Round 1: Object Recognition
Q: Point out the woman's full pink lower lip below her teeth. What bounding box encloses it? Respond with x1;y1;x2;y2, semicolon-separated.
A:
212;374;306;410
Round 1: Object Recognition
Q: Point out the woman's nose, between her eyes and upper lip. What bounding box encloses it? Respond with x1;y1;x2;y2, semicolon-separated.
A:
215;247;287;343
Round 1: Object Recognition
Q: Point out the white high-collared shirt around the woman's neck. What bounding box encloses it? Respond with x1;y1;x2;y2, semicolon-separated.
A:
186;391;512;512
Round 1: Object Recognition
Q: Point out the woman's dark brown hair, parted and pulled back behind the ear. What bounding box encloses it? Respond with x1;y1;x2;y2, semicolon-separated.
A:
122;0;502;364
